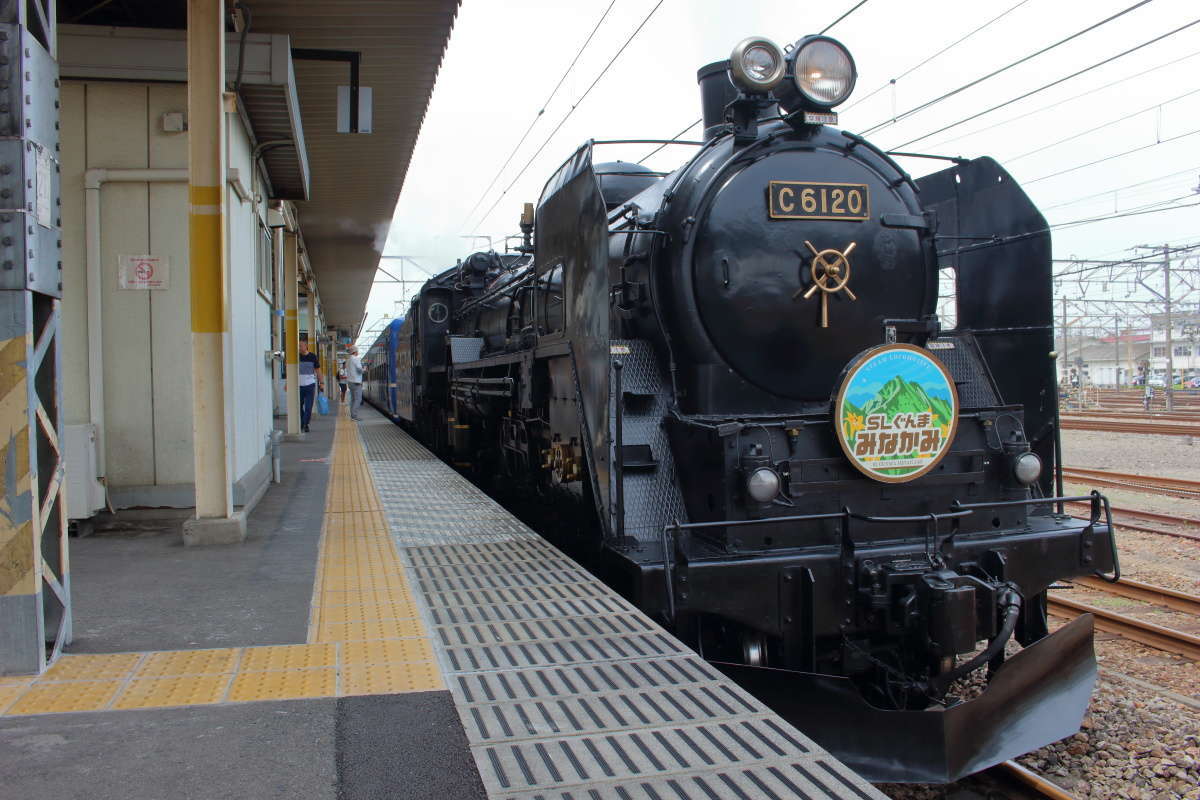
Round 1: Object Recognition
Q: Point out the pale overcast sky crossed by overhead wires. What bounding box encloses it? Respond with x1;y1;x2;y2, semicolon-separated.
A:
355;0;1200;340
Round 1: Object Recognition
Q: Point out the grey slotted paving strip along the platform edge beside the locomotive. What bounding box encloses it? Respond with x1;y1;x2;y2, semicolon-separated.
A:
359;417;882;800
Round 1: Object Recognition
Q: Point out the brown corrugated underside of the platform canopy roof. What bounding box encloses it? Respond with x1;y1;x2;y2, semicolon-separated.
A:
58;0;460;329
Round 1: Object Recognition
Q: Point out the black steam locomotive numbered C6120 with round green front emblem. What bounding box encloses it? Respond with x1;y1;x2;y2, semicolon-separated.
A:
368;36;1118;781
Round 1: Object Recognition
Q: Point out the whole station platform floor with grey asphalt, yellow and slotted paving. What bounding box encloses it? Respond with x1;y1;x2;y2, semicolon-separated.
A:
0;409;883;800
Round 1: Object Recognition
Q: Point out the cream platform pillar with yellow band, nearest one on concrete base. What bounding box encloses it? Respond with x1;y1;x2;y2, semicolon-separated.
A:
184;0;246;545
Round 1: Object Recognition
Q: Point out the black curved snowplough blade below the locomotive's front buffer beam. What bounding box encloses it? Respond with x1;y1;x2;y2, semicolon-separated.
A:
714;614;1097;783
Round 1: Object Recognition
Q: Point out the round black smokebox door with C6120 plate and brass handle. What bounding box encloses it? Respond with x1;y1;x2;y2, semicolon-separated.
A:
679;137;935;401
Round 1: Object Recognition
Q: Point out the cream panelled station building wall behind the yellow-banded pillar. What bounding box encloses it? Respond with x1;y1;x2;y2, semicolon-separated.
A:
61;80;275;507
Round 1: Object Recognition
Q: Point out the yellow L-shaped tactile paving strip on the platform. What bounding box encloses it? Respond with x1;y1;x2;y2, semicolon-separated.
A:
0;415;444;716
